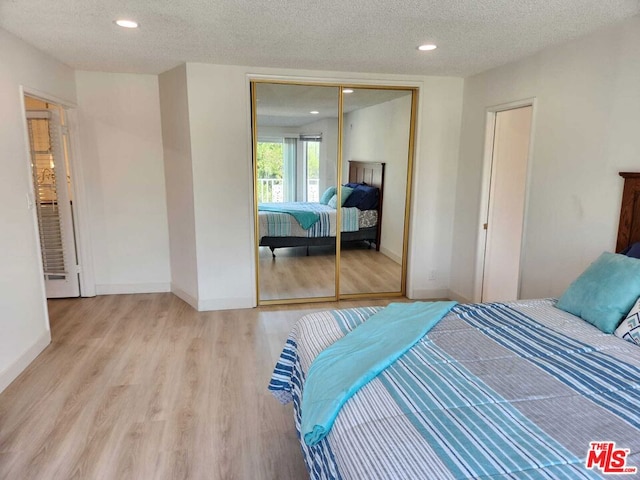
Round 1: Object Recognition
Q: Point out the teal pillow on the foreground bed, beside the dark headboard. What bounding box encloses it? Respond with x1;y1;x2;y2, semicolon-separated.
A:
556;252;640;333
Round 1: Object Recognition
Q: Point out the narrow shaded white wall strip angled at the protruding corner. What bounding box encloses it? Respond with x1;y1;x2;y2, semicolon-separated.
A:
158;65;198;308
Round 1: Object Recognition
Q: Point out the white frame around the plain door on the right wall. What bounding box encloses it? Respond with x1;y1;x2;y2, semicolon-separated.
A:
473;97;537;302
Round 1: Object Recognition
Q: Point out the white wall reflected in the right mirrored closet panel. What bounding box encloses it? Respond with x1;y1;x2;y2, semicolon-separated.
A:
342;95;411;263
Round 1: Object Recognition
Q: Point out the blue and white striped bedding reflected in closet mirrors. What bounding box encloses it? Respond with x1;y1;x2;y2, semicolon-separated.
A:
258;202;360;238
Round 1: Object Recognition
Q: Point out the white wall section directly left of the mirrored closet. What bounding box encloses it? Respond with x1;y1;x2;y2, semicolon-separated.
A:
187;63;256;310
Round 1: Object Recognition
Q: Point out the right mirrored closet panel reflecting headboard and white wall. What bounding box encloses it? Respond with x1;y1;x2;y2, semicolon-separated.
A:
340;88;413;295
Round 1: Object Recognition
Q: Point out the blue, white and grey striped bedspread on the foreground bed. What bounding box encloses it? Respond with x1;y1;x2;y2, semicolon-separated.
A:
269;300;640;479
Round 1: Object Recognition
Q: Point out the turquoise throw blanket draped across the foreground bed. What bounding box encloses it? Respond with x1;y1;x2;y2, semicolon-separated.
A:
301;302;456;445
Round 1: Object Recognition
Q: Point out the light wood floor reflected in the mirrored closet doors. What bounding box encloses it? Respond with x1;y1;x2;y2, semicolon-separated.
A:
259;246;402;300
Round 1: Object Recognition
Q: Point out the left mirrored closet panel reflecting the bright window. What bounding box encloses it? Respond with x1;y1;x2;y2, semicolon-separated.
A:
254;83;339;300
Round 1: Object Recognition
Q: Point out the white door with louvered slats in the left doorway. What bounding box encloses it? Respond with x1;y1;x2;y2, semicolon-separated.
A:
27;108;80;298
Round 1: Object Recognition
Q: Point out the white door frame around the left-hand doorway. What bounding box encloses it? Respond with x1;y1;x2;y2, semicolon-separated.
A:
19;85;96;297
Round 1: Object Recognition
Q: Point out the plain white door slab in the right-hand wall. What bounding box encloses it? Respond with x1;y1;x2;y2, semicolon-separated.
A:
481;106;533;302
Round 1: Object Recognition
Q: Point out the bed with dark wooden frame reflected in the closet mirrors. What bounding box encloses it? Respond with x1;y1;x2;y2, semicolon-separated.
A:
258;160;385;258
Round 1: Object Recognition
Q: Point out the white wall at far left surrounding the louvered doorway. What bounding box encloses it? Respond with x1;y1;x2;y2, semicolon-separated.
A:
0;29;76;391
